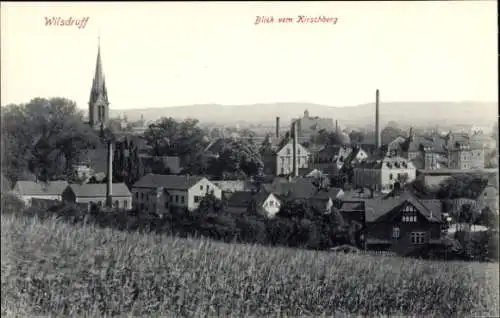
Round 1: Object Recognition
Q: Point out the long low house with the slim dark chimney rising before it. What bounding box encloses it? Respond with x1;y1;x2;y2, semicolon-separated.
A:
62;183;132;210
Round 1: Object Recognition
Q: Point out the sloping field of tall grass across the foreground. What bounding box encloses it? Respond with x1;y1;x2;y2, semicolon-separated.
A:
1;215;499;317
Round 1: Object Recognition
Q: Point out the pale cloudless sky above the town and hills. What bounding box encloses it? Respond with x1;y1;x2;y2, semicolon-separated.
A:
1;1;498;109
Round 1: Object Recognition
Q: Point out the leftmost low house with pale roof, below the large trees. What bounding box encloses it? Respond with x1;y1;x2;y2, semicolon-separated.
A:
12;181;68;206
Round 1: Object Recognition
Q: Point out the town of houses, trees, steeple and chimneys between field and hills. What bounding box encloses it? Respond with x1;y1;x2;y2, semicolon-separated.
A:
2;40;498;261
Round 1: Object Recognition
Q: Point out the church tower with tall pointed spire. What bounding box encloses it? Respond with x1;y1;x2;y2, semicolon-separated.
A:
89;41;109;129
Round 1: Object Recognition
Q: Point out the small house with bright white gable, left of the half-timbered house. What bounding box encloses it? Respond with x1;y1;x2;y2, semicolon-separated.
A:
227;191;281;218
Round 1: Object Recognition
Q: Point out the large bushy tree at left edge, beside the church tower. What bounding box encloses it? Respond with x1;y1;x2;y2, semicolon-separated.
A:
2;97;99;180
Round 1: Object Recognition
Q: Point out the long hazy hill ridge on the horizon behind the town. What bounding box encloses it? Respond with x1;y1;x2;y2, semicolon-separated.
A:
110;102;498;127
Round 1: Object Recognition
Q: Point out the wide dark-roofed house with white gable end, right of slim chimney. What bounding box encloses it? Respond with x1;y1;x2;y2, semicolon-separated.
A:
132;173;222;214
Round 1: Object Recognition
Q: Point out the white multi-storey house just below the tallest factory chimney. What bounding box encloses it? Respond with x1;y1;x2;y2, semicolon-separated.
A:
353;157;416;193
